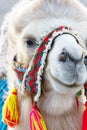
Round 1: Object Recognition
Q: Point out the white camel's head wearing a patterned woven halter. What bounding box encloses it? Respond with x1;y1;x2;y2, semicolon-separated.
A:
1;0;87;129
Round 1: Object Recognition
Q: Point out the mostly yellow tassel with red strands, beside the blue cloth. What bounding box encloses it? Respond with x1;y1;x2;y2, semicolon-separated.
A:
2;88;19;127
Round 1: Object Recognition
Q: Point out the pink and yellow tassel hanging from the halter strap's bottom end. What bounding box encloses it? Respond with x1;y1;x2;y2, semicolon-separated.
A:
30;105;47;130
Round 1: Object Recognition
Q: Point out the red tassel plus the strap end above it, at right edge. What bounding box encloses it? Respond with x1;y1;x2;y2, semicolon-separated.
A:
82;83;87;130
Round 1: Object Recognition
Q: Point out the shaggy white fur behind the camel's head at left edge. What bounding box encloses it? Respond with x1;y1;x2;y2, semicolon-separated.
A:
0;15;9;78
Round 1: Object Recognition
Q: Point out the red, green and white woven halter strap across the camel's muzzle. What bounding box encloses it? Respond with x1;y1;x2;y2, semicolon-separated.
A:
14;26;85;102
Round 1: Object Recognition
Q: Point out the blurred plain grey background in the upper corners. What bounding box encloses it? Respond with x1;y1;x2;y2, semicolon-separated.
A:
0;0;87;26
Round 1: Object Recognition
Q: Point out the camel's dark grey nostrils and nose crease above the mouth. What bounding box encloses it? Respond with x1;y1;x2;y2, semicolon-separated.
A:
59;49;83;64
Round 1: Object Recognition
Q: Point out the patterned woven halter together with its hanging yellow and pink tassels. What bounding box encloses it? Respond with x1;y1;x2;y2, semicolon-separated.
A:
3;26;85;130
